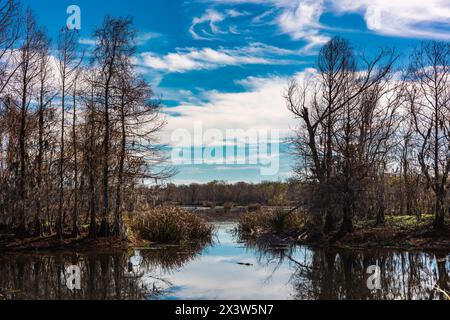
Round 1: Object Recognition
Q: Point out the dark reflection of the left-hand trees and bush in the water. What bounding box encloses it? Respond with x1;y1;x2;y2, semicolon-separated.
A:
0;248;204;300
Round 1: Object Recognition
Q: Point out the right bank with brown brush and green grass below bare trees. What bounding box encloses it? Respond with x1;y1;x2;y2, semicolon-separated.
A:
238;213;450;252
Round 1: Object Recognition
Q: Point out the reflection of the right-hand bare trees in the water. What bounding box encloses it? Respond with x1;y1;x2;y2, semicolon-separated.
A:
249;243;450;300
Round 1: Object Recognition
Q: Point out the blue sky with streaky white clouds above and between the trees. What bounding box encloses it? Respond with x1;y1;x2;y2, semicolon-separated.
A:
22;0;450;184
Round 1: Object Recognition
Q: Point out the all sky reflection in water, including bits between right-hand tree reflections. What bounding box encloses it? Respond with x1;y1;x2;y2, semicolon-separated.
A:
136;223;450;300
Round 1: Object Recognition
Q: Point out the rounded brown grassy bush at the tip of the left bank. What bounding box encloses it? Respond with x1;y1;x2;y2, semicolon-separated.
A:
131;207;213;244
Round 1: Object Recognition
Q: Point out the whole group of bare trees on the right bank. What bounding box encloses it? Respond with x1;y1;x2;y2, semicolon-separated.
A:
285;38;450;233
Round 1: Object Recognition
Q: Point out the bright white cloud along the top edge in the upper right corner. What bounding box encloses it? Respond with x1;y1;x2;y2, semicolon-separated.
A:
209;0;450;43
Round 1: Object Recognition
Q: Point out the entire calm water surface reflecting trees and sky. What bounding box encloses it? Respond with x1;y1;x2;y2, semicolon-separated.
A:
0;223;450;300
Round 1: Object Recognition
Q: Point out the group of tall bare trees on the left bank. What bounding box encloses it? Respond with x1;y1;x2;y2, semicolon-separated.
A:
0;0;171;239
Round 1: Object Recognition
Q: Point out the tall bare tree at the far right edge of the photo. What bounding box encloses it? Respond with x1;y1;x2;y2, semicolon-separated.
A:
409;41;450;230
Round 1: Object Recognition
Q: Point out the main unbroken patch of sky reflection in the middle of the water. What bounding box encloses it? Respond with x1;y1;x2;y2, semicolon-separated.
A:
143;224;306;300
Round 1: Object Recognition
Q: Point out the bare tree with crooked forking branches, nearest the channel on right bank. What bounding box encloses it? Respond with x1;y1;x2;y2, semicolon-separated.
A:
286;38;396;233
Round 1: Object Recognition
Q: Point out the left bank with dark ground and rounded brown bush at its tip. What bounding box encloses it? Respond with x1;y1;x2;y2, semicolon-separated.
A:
0;207;213;251
